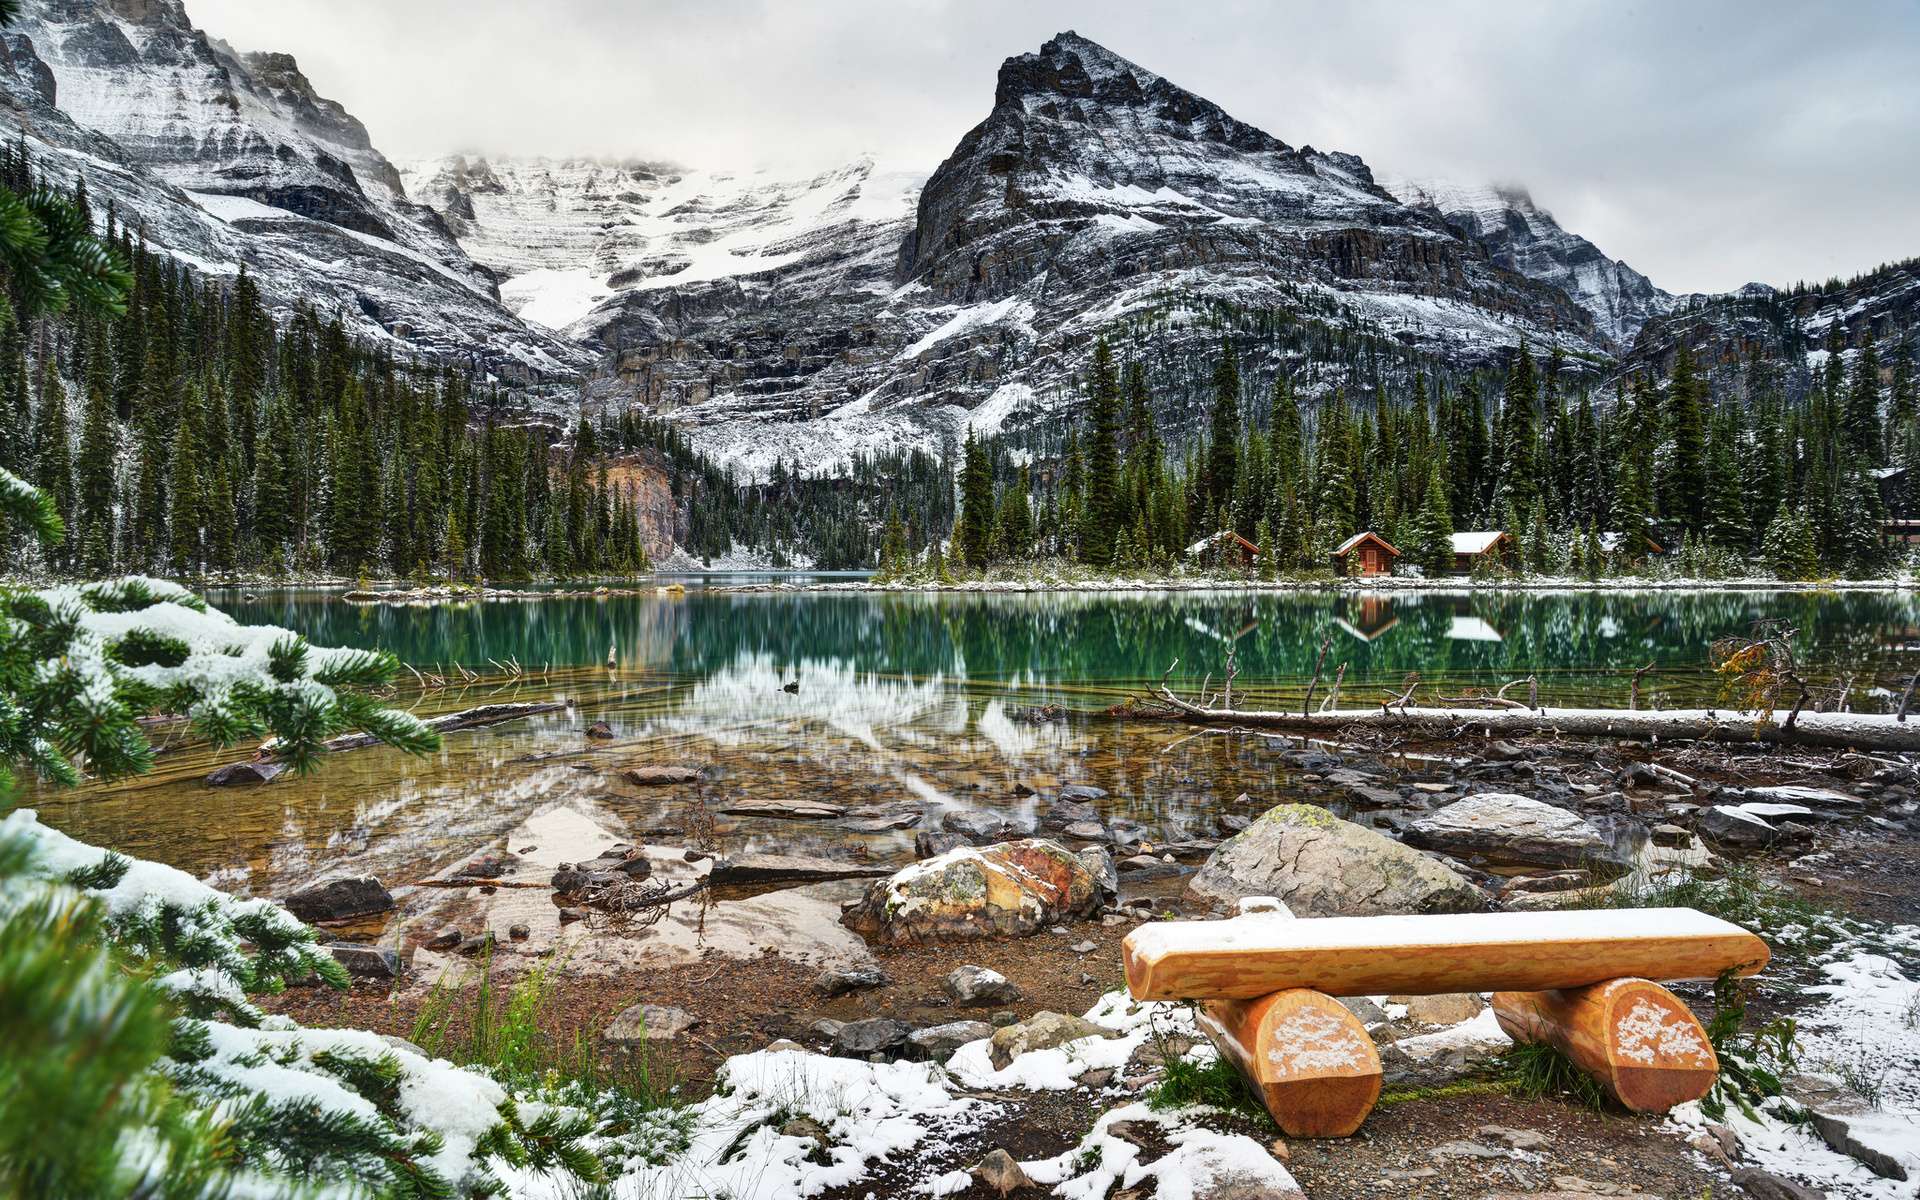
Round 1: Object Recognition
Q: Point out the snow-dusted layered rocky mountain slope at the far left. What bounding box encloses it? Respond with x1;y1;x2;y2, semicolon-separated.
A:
0;0;588;378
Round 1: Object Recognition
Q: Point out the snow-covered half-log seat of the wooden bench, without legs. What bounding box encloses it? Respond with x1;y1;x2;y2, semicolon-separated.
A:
1121;908;1768;1000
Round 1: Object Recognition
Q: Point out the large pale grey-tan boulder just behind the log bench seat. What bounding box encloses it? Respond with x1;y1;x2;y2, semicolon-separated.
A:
1187;804;1486;916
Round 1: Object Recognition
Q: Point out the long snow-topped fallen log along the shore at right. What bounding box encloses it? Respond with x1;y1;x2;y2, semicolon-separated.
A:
1160;687;1920;751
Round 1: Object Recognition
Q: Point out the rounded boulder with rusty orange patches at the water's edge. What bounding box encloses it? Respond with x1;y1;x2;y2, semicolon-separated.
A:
841;837;1100;945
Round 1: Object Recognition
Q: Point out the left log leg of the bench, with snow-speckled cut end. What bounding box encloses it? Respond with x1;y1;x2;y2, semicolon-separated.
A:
1198;987;1380;1137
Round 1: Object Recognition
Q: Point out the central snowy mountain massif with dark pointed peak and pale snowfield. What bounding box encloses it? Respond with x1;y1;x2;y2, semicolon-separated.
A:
416;33;1601;474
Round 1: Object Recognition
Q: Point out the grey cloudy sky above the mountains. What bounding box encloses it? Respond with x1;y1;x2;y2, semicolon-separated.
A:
188;0;1920;292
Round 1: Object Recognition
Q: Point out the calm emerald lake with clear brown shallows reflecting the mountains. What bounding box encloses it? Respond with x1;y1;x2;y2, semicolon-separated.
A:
21;580;1920;921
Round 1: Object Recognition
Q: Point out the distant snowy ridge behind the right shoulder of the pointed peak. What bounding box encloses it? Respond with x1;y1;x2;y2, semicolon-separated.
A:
1386;179;1688;353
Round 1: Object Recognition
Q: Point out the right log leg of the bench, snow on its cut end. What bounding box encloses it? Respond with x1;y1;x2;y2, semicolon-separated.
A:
1494;979;1720;1112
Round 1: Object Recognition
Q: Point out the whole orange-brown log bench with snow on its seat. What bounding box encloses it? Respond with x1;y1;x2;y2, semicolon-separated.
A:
1121;908;1768;1137
